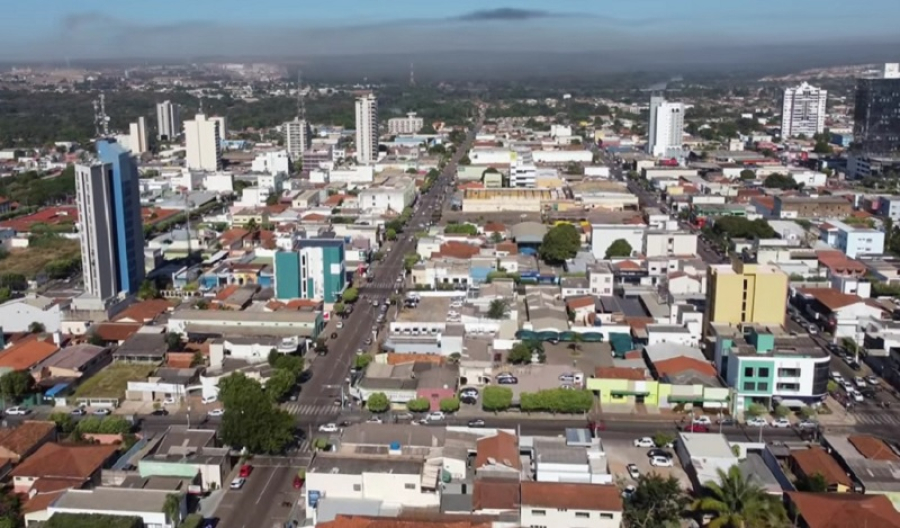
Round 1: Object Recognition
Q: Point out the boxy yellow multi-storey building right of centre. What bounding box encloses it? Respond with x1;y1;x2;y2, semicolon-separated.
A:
706;259;788;327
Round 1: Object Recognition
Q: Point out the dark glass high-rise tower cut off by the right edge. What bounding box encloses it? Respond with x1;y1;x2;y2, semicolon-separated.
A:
853;63;900;156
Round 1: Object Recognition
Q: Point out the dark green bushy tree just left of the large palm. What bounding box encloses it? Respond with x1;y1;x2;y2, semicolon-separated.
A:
624;473;688;528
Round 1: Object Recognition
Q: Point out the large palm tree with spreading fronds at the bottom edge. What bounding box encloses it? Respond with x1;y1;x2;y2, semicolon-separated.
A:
690;466;788;528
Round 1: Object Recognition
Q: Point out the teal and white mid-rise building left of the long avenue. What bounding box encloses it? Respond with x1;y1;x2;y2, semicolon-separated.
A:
274;238;347;303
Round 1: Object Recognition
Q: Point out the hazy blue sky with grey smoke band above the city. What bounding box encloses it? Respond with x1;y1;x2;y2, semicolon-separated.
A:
0;0;900;61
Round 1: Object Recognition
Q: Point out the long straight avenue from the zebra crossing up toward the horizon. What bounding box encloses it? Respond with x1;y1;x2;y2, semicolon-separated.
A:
297;107;484;423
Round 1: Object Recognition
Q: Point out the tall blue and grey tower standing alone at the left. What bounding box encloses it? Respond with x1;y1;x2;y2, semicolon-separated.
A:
75;139;144;300
